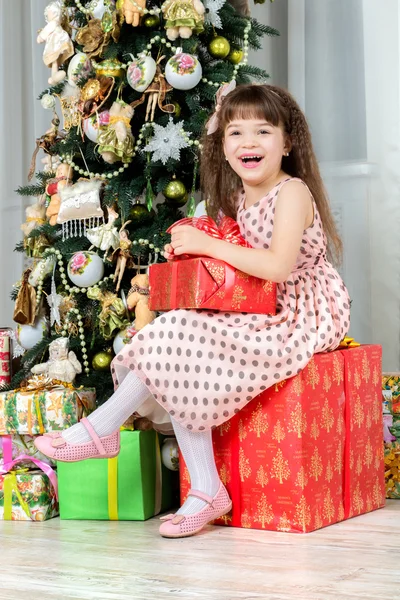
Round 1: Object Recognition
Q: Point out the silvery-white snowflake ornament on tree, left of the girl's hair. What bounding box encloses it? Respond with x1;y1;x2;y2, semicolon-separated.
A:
144;119;190;165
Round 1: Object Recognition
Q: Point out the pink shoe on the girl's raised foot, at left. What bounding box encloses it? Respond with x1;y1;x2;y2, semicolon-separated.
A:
35;418;120;462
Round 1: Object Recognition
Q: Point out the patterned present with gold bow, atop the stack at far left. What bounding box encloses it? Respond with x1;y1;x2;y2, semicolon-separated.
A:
0;376;96;435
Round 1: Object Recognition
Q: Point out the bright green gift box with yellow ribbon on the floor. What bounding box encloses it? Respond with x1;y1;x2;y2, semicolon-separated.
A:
57;431;176;521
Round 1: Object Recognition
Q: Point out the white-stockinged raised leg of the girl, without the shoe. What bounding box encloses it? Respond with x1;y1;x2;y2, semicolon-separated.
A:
62;371;150;444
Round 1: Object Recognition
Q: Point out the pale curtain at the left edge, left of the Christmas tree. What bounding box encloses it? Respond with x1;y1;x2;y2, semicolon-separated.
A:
0;0;51;326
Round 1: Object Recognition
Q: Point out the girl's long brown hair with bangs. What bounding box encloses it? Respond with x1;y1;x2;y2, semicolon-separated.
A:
200;84;342;263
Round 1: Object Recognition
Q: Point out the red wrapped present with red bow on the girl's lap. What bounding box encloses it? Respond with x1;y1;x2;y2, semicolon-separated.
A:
149;216;276;314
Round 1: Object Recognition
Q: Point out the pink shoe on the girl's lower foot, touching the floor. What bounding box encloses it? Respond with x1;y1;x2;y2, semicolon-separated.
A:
159;483;232;538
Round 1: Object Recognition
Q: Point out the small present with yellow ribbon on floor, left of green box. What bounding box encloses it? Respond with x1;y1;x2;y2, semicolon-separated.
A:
0;455;58;521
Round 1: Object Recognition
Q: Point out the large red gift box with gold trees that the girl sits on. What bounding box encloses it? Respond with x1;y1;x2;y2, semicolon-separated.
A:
180;345;385;532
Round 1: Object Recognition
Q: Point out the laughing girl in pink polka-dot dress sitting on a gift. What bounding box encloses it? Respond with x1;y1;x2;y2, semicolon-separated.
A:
36;85;349;537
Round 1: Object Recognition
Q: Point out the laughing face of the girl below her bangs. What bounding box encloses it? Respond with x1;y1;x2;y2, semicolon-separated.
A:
223;119;290;186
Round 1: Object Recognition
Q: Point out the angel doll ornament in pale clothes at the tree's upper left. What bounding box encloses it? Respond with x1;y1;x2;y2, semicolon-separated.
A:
37;0;74;85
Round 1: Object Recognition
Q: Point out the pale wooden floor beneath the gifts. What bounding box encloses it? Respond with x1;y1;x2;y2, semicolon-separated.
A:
0;500;400;600
